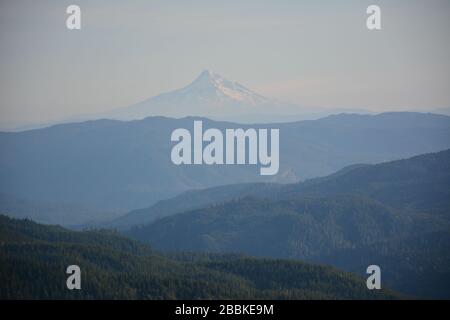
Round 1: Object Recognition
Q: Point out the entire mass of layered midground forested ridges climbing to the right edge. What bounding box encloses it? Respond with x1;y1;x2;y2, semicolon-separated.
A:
125;150;450;298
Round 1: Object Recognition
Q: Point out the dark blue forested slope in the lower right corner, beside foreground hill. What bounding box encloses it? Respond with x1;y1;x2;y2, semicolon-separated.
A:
321;230;450;299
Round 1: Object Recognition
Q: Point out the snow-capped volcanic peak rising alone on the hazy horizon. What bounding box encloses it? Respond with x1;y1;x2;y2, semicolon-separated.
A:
102;70;370;123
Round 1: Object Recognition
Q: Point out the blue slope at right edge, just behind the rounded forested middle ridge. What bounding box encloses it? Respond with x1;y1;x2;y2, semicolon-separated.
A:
280;150;450;217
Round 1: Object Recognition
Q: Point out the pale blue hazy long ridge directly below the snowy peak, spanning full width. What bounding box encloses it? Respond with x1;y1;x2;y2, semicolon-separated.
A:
0;113;450;225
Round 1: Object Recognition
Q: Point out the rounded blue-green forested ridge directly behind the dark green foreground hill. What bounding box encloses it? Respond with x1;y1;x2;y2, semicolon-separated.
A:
130;197;415;259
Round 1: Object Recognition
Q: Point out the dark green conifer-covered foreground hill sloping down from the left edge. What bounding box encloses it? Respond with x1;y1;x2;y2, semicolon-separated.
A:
0;215;397;299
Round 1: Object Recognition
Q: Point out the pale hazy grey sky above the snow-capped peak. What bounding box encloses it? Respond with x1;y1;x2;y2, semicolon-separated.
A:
0;0;450;123
